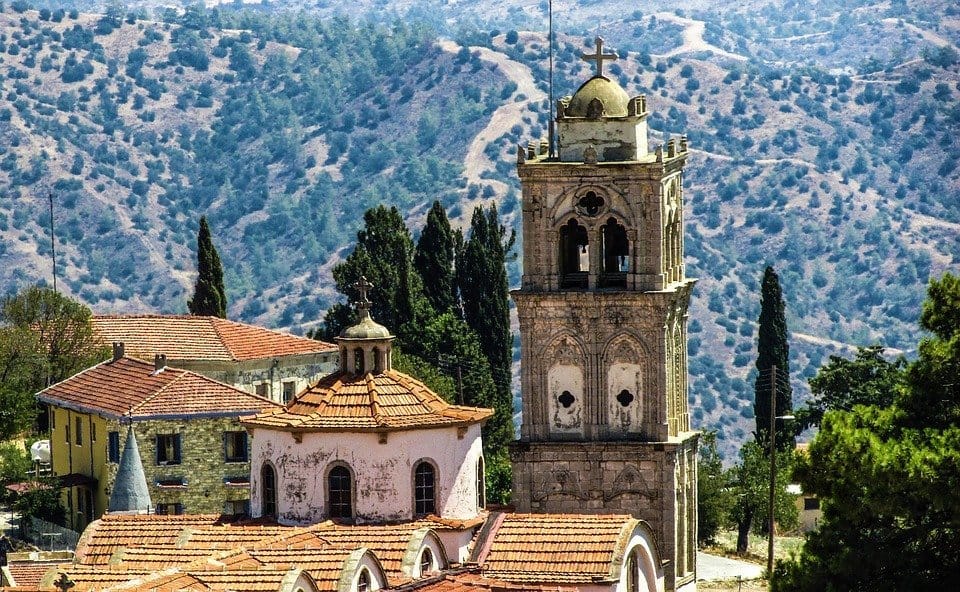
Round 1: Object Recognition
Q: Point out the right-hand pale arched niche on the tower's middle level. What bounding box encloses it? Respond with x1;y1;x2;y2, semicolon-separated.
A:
603;334;650;438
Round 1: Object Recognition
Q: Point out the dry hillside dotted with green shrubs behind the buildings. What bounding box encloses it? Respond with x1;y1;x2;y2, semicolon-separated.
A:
0;0;960;453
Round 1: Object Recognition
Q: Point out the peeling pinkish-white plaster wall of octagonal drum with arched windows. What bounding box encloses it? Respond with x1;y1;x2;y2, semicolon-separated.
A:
250;425;483;524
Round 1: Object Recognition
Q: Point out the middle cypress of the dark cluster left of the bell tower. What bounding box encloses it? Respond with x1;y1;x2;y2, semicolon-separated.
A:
413;201;457;314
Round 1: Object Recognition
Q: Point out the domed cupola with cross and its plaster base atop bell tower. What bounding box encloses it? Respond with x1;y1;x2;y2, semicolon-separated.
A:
557;37;647;162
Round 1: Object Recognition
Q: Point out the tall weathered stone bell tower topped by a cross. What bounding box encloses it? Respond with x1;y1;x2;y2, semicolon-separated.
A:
511;38;698;590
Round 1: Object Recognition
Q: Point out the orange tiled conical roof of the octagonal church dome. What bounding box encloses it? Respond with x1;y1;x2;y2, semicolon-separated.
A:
243;370;493;431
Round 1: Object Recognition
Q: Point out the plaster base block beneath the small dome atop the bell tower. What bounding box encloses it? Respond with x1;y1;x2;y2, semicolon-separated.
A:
559;118;647;162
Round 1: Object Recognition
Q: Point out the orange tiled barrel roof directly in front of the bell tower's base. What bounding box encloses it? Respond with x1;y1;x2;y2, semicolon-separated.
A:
481;514;639;584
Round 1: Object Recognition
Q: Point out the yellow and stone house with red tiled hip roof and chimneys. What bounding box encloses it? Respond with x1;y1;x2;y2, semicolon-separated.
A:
37;345;279;530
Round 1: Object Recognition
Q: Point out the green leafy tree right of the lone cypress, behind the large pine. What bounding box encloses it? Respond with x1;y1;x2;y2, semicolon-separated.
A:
797;345;907;428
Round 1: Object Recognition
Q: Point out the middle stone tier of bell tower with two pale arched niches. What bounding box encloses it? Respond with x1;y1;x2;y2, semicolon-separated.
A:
513;290;693;441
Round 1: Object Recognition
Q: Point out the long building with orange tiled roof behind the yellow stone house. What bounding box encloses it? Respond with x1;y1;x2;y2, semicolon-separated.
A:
92;315;337;403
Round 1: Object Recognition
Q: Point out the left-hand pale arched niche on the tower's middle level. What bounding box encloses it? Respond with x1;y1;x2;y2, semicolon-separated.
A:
542;335;586;438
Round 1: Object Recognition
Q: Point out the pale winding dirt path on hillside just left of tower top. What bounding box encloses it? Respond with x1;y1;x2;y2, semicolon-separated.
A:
439;39;547;215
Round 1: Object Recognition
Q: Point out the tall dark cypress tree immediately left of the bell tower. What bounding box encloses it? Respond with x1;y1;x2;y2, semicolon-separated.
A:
457;205;515;444
